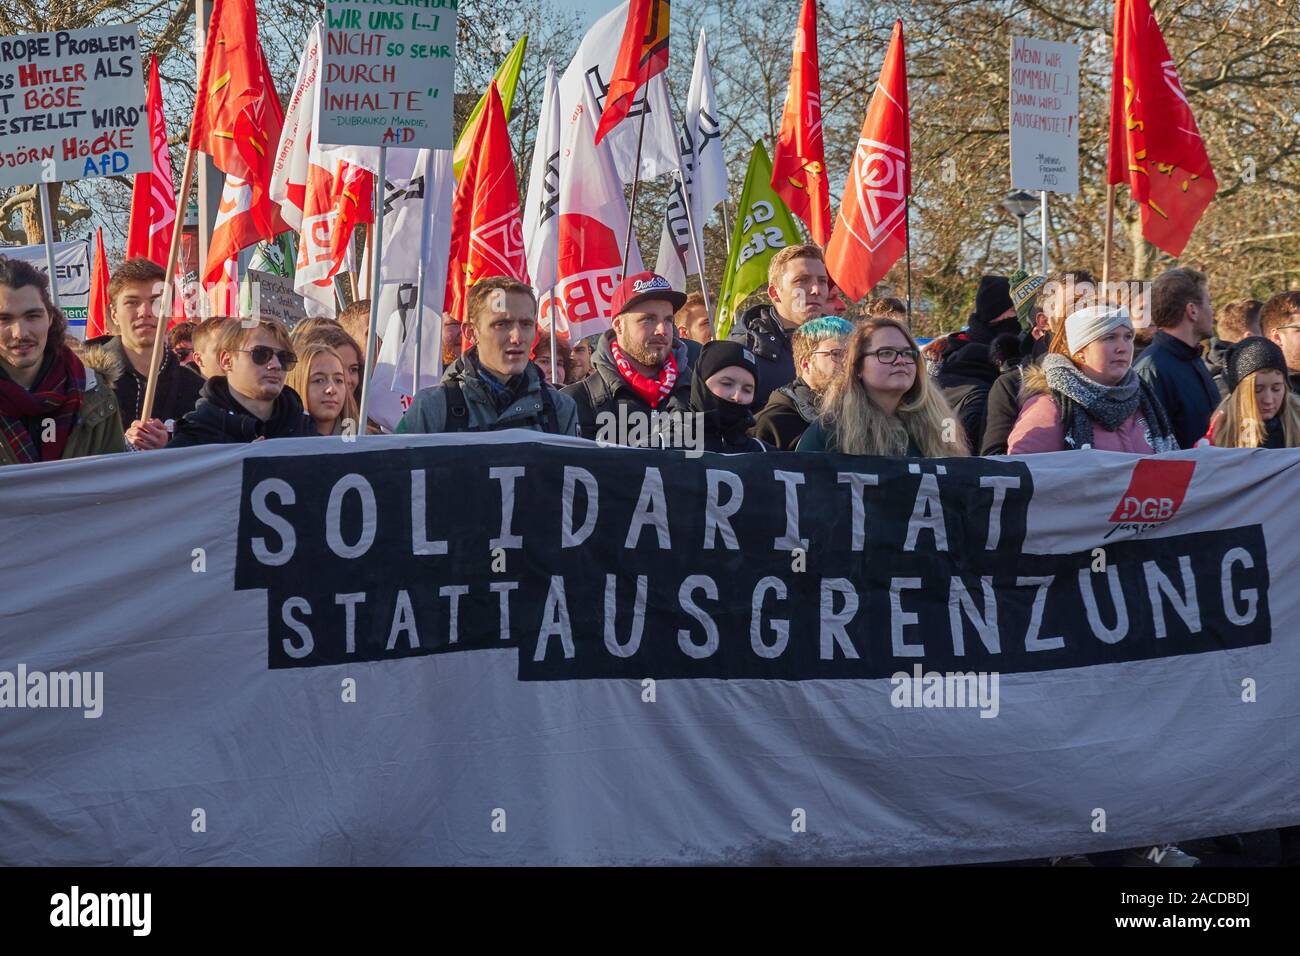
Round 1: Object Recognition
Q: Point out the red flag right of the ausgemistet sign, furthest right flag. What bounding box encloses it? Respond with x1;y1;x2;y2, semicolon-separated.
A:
1108;0;1218;256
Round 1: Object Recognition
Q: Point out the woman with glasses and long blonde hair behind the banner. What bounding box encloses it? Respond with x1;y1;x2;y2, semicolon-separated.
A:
796;317;970;458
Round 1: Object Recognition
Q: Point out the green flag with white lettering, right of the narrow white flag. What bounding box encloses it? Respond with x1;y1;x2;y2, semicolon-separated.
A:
718;140;803;338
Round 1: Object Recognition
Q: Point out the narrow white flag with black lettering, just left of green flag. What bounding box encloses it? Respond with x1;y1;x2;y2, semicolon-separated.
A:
658;30;727;290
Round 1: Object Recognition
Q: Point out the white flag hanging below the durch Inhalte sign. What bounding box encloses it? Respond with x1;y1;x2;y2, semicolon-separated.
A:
369;150;455;431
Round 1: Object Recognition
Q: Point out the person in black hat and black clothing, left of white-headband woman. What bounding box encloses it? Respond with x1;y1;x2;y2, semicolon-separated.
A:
935;276;1021;453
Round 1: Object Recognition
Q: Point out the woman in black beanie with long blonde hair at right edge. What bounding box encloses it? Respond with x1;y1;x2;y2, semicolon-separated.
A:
1205;336;1300;449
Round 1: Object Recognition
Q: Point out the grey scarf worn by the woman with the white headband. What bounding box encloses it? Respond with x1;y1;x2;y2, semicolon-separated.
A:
1041;352;1178;453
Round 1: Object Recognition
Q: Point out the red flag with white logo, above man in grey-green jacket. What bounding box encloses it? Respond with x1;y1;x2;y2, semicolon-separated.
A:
446;82;528;321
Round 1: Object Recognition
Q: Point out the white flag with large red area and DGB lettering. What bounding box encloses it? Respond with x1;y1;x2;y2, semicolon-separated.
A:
541;83;642;342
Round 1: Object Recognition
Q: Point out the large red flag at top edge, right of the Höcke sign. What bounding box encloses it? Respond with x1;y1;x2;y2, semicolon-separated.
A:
190;0;289;282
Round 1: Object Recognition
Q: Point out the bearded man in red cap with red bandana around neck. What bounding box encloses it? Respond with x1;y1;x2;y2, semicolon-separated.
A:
563;272;690;445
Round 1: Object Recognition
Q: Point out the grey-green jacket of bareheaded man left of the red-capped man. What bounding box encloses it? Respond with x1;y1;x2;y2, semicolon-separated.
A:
397;346;577;434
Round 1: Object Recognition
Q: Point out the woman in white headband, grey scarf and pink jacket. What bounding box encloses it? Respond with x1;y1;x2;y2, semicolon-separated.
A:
1006;306;1178;455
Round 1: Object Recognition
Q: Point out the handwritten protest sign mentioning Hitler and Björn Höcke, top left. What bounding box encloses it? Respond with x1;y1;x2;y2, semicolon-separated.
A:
0;23;153;187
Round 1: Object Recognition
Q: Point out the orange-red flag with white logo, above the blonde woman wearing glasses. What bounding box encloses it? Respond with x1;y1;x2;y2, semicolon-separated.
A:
826;20;911;299
